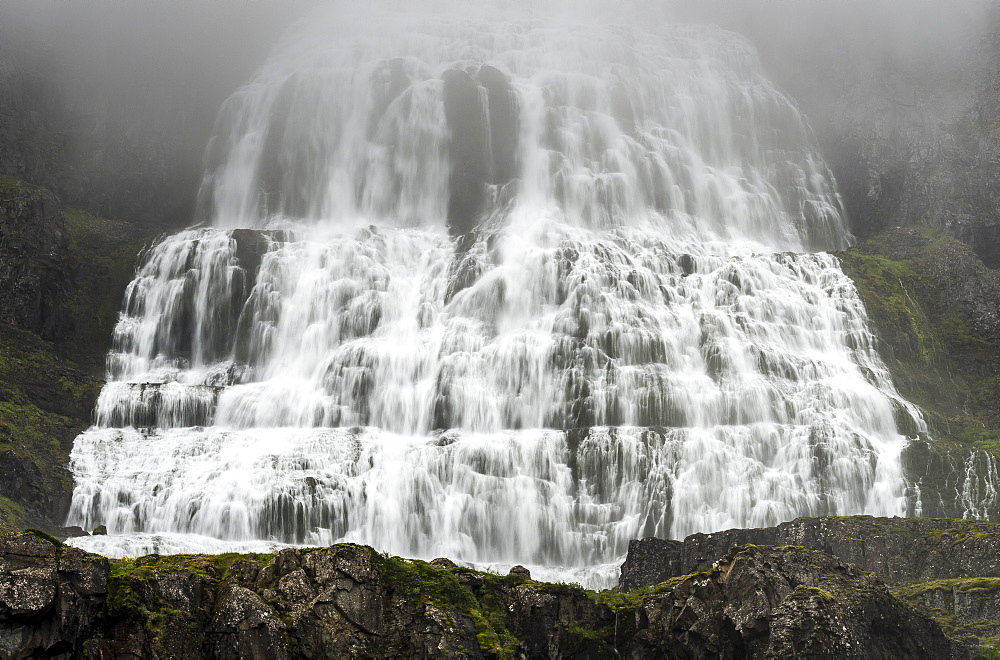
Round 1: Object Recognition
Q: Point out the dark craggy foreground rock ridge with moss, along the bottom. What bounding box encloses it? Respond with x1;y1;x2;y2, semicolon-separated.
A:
0;534;971;658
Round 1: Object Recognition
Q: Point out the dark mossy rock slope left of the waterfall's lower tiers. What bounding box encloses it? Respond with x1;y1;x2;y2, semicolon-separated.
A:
0;177;154;534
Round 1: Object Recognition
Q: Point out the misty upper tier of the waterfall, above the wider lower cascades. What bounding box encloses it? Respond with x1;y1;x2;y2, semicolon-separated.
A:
199;14;851;252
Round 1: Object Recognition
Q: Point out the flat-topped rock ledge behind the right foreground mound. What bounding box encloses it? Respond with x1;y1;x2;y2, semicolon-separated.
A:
620;516;1000;652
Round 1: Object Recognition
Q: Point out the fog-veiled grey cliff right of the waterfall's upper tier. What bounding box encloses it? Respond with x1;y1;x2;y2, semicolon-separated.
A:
772;11;1000;267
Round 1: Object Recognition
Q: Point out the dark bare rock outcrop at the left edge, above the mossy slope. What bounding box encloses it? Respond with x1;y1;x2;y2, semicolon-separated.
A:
0;177;67;339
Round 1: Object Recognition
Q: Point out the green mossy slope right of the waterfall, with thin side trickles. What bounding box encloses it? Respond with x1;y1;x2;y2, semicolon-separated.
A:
838;228;1000;517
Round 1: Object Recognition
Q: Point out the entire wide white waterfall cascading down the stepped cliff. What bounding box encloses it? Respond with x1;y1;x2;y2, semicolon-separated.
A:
69;10;923;586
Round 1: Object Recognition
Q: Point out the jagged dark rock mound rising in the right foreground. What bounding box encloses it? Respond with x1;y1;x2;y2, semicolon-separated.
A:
630;546;970;658
